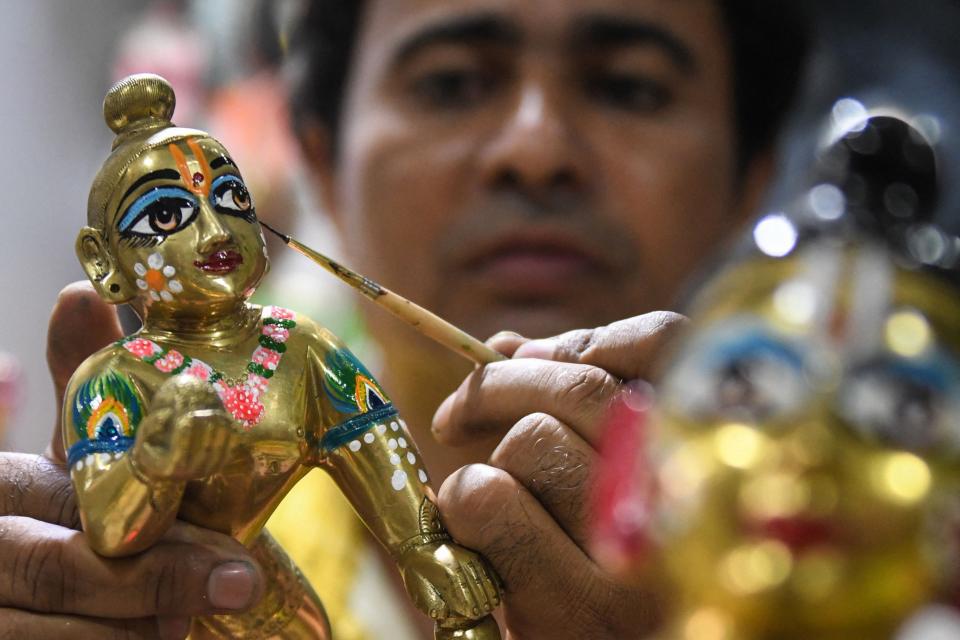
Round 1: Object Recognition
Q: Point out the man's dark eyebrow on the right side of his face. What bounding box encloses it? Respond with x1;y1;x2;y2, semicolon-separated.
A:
573;15;697;73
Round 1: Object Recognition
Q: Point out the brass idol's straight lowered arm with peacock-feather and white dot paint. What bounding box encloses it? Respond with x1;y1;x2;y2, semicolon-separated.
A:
307;342;500;638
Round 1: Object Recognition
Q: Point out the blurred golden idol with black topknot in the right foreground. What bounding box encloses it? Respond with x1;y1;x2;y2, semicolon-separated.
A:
596;112;960;640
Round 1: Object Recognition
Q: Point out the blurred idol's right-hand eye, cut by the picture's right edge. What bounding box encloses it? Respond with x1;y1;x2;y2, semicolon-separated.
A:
836;356;960;453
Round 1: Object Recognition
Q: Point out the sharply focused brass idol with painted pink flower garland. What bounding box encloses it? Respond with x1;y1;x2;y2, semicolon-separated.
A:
63;74;500;639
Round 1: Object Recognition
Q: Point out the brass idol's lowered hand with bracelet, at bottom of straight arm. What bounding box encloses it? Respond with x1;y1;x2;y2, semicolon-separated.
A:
398;541;500;620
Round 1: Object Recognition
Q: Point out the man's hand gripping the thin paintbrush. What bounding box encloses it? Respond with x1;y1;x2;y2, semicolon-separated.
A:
433;313;685;640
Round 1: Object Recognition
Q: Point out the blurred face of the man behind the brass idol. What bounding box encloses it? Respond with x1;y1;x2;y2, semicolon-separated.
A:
327;0;752;337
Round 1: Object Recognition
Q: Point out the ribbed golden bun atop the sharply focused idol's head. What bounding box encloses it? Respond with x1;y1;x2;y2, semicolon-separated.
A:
103;73;177;142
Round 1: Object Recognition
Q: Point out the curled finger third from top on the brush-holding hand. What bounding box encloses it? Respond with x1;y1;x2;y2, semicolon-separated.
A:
490;413;597;550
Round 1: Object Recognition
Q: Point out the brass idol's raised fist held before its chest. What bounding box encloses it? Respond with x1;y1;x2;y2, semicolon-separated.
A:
131;375;239;481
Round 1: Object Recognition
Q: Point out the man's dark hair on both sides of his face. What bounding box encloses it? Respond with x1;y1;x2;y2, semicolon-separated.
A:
289;0;807;166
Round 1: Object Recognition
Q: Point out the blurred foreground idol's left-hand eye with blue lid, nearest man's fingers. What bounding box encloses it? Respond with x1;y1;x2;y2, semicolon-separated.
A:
663;319;809;424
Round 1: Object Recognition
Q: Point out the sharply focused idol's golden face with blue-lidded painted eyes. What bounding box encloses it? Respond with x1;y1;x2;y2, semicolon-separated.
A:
107;136;267;311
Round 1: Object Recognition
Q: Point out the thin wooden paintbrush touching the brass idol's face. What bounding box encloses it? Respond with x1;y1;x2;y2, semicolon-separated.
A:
260;220;507;365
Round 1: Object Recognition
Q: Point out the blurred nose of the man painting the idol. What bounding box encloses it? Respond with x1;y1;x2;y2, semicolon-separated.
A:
481;84;589;196
